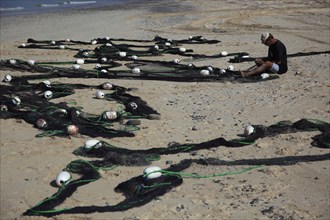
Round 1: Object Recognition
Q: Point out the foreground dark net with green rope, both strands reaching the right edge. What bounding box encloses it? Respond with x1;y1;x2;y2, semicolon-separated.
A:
24;119;330;216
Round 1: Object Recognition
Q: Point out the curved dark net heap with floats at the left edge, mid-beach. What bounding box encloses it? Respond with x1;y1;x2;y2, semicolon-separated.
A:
0;78;160;138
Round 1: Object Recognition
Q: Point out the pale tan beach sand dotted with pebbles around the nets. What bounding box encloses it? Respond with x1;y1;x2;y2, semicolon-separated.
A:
0;0;330;220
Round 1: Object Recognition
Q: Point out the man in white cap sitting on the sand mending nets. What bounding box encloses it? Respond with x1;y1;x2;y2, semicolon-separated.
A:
240;32;288;77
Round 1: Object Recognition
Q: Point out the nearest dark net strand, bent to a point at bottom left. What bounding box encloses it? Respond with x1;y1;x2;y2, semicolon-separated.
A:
24;149;330;216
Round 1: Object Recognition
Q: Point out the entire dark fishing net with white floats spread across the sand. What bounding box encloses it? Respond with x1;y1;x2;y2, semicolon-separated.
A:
0;36;330;216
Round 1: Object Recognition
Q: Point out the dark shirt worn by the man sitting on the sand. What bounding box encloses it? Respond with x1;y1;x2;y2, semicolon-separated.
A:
268;40;288;74
